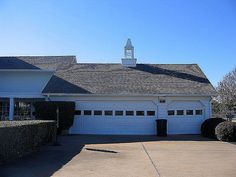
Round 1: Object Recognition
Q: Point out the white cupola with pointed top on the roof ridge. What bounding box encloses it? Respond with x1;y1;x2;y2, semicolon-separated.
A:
121;39;137;67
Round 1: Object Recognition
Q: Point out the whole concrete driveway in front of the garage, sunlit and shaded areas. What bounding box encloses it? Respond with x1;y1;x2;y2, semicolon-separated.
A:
0;135;236;177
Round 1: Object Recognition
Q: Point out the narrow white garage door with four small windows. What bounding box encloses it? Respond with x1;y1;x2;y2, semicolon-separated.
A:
167;101;204;134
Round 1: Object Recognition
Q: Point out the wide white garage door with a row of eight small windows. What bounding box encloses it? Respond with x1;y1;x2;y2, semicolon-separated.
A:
70;101;157;135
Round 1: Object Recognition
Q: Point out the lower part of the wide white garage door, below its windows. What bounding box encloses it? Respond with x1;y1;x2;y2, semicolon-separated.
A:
70;116;156;135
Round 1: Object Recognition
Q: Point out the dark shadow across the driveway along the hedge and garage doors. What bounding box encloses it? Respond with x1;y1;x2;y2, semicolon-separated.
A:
0;135;211;177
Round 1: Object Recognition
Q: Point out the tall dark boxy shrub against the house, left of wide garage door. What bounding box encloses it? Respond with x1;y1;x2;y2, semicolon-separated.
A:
34;101;75;134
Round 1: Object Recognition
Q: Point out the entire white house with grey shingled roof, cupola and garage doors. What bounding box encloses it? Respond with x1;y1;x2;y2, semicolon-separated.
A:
0;39;215;134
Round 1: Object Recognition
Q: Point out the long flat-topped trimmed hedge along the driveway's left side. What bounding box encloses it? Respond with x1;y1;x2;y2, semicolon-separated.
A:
0;120;56;164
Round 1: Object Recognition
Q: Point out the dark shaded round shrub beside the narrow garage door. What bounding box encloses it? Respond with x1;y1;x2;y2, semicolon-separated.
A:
201;118;225;138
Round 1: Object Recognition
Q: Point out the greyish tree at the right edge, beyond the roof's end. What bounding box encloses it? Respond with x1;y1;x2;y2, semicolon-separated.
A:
216;67;236;114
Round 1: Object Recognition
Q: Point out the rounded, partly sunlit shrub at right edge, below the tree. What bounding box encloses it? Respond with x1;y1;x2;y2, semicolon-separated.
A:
215;121;236;142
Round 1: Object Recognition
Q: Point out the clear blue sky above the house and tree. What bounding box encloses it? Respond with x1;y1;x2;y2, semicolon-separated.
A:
0;0;236;85
